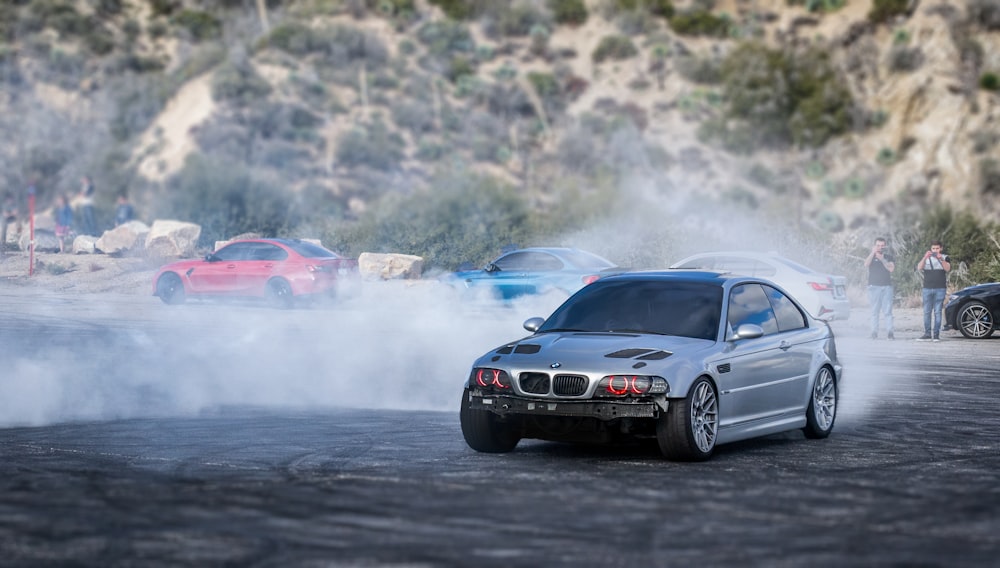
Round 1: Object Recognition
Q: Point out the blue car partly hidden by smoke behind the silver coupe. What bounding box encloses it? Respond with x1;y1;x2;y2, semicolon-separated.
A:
446;247;622;300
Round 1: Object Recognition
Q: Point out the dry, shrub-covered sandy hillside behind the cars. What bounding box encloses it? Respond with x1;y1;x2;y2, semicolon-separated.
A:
0;0;1000;272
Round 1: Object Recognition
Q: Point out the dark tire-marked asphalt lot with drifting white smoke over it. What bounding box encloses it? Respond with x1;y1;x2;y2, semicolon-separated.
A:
0;288;1000;566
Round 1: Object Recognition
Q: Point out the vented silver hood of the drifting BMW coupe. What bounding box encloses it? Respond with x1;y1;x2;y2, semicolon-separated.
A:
477;332;715;373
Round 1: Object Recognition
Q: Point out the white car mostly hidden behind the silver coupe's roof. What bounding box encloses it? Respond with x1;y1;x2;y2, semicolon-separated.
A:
670;251;851;320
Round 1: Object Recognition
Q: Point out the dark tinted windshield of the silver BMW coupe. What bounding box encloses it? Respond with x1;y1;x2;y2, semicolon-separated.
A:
538;280;722;341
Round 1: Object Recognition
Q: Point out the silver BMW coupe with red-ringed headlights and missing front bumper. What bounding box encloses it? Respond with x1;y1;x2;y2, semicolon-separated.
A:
460;270;842;461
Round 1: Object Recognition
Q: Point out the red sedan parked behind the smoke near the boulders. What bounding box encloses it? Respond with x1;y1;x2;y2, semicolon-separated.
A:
153;239;358;308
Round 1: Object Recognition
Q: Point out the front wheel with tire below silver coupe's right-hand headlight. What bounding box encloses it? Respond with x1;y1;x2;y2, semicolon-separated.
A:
656;377;719;461
